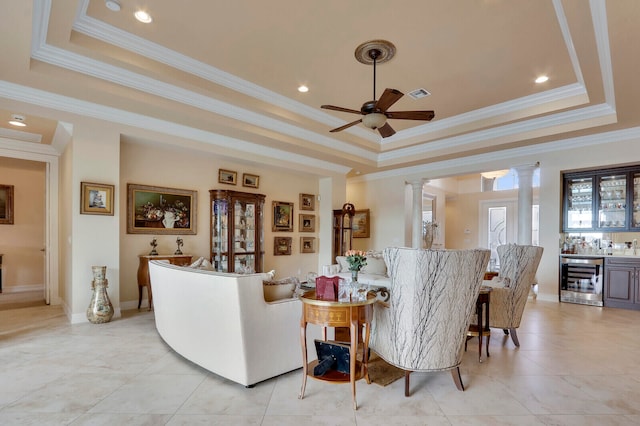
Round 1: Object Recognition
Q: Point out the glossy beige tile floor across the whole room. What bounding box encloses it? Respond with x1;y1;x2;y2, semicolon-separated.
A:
0;300;640;425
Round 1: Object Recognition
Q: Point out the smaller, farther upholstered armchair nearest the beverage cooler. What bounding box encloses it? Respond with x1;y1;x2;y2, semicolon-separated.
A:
489;244;544;347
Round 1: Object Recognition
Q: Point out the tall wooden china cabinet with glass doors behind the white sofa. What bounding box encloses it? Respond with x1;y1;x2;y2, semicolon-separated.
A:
209;189;265;273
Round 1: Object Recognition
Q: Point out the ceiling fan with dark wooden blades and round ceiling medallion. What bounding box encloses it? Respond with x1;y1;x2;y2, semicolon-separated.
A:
321;40;435;138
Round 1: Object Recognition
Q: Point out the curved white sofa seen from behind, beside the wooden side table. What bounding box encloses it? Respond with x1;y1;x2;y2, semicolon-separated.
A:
149;261;321;386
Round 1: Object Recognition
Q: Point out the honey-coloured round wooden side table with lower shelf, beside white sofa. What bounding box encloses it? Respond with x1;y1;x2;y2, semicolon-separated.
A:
299;290;376;410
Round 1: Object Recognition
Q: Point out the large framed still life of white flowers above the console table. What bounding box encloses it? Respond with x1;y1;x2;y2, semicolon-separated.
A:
127;183;198;235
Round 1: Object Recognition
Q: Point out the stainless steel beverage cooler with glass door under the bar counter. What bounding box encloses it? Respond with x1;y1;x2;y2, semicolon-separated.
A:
560;255;604;306
